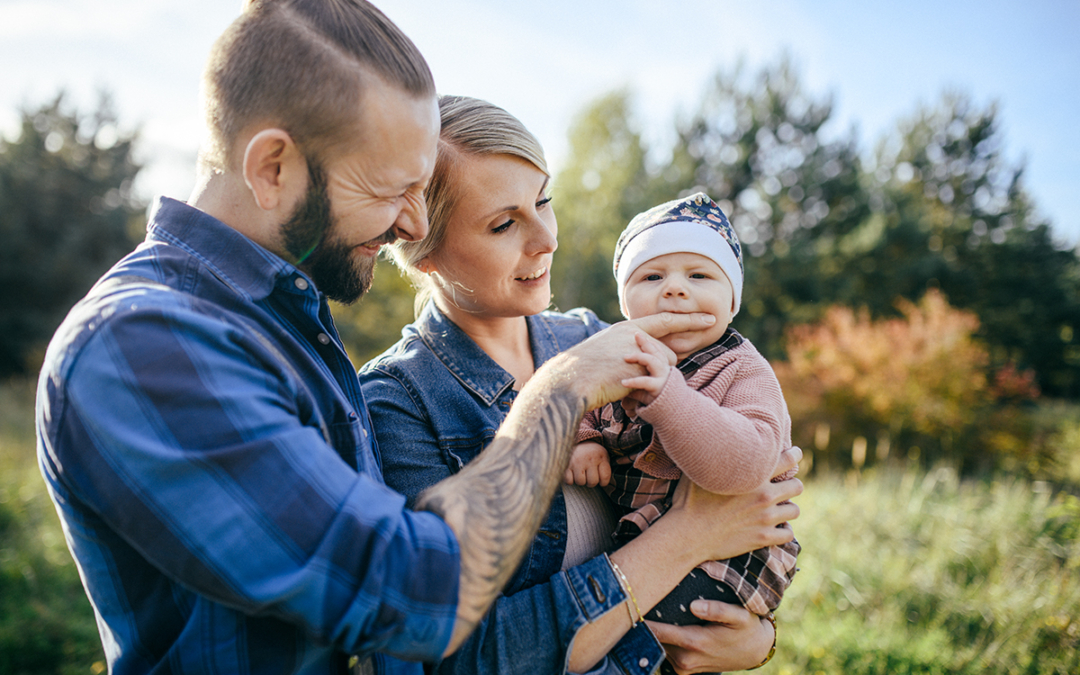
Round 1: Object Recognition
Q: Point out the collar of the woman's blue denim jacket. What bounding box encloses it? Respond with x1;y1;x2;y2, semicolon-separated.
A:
410;302;558;406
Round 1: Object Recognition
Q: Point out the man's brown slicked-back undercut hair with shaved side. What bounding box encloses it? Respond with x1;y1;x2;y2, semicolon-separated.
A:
200;0;435;171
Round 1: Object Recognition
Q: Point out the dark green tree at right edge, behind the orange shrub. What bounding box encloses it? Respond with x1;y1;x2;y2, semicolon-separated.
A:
864;93;1080;397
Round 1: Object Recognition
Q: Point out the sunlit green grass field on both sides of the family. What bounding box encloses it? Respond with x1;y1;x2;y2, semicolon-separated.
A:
0;381;1080;675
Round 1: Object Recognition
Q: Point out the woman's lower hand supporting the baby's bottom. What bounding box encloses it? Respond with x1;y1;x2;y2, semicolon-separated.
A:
647;600;775;674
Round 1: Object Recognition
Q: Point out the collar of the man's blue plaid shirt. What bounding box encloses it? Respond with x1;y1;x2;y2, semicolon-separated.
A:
146;197;302;302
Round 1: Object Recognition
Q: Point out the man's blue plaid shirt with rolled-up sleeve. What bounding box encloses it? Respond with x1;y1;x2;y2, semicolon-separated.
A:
37;200;459;675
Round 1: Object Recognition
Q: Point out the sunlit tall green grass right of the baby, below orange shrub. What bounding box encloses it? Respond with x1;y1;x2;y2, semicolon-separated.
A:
762;468;1080;675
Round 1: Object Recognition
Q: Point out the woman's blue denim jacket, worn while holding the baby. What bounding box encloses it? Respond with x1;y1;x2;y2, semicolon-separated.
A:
360;303;663;675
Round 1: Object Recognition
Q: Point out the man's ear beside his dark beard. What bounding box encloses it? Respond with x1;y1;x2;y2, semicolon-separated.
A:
243;129;308;211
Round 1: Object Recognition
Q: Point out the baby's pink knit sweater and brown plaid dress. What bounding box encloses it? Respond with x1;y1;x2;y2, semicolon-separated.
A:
577;327;800;623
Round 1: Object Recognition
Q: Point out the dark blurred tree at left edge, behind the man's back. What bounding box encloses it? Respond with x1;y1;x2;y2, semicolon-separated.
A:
0;94;143;376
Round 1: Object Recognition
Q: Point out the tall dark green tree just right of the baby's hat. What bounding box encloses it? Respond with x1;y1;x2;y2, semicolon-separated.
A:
659;58;868;356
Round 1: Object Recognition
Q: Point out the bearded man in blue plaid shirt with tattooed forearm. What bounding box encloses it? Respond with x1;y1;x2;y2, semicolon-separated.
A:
37;0;725;674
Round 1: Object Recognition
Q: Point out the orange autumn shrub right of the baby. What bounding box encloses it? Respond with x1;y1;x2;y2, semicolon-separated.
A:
777;291;1039;471
